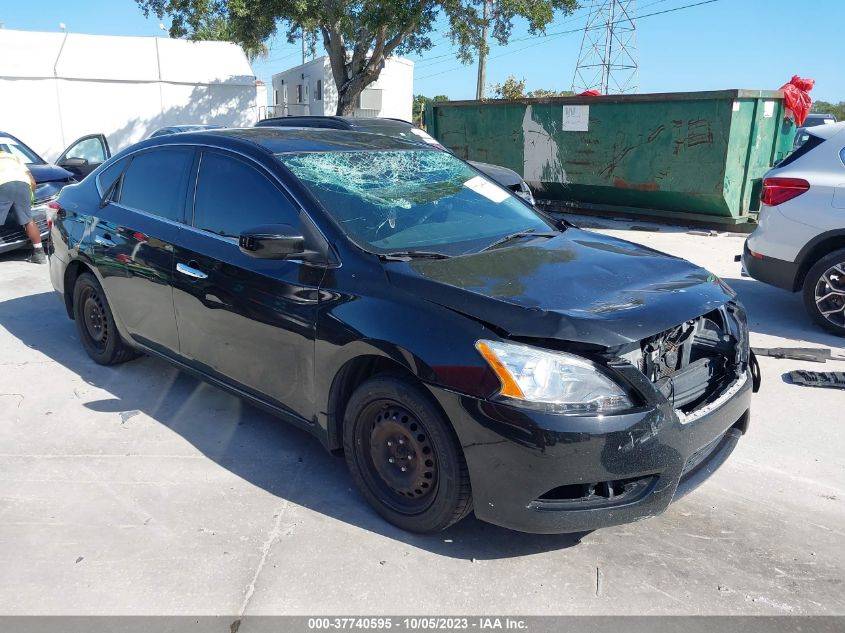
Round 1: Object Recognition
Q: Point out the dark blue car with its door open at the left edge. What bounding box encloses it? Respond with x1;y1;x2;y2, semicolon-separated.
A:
0;132;110;253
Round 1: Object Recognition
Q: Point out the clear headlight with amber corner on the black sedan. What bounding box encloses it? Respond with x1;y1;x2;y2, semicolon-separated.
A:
475;340;633;413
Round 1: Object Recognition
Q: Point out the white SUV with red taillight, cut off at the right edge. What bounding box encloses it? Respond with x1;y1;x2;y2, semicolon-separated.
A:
742;122;845;336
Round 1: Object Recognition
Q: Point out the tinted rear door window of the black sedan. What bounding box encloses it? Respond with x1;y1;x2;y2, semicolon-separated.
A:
120;149;194;222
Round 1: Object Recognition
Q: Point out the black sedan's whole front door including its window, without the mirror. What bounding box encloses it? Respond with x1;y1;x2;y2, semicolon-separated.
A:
173;150;324;420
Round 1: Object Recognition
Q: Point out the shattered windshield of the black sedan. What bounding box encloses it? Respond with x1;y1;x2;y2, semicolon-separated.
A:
278;149;550;255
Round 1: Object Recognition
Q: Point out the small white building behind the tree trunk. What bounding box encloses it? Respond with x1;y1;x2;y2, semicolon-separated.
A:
270;56;414;121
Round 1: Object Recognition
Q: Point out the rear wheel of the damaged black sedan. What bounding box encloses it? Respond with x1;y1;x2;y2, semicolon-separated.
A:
73;273;140;365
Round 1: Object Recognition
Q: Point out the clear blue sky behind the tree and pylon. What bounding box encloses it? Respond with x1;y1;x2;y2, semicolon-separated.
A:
0;0;845;102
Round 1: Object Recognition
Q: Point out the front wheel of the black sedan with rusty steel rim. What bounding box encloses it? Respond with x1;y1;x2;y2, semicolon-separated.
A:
343;376;472;533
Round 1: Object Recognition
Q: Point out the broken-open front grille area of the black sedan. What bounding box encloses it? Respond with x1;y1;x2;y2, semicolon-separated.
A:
626;306;747;414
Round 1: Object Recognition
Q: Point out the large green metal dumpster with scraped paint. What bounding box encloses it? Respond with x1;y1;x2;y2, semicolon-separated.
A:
426;90;795;224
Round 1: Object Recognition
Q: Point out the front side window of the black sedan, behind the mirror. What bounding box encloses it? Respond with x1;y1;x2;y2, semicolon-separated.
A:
194;152;299;237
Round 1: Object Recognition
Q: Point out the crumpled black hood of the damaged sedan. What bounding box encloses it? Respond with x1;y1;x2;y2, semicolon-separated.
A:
386;228;735;347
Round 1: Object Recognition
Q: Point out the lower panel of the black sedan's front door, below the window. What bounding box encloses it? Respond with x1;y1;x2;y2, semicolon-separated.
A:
173;231;323;419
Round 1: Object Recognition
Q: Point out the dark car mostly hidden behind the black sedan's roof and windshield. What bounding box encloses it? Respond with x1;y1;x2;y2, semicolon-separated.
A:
256;116;535;206
